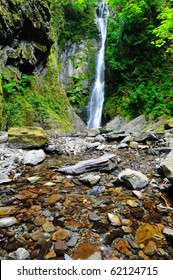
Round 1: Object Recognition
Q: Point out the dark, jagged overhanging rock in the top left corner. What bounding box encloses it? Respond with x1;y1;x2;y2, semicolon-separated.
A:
0;0;53;74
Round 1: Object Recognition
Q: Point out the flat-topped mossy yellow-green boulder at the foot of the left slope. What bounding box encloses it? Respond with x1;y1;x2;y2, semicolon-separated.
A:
8;127;49;149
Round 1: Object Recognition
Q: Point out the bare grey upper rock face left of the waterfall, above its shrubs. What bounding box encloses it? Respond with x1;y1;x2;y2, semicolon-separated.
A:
58;39;97;94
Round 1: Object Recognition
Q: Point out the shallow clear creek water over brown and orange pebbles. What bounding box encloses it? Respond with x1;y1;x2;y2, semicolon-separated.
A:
0;149;173;259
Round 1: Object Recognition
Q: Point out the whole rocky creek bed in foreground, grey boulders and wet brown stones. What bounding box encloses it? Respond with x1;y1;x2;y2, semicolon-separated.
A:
0;116;173;260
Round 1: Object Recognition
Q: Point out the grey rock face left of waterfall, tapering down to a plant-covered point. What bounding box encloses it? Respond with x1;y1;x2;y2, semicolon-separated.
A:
58;38;97;120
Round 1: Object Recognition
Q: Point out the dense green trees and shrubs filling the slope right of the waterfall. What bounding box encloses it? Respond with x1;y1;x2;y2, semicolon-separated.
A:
104;0;173;118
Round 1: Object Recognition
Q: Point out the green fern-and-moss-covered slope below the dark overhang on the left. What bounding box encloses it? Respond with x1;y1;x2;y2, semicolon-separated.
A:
1;66;70;130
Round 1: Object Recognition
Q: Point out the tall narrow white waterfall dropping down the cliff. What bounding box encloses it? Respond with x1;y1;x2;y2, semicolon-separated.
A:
87;0;109;128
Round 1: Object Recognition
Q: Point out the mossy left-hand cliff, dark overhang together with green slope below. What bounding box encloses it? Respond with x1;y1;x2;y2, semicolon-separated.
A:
0;0;94;131
